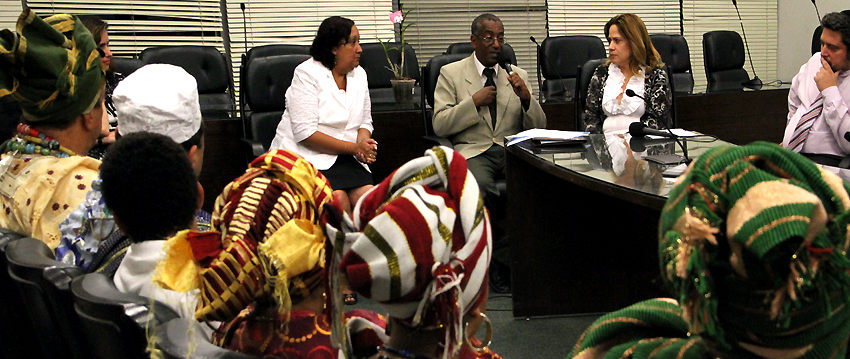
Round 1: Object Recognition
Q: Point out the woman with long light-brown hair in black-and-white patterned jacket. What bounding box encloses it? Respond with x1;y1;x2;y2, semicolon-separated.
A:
584;14;672;133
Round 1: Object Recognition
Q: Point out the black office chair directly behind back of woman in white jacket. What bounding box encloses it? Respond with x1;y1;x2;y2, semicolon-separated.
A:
240;55;310;161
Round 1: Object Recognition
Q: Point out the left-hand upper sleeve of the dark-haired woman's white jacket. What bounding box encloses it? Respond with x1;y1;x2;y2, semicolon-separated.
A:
286;64;320;143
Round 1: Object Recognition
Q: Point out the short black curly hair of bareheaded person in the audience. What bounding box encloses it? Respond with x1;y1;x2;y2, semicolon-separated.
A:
100;132;199;243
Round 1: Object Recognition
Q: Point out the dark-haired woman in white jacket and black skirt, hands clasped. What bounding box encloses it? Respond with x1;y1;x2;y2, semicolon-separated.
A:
271;16;378;212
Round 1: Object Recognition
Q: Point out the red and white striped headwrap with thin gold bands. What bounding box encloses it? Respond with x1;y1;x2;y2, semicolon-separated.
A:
326;147;492;357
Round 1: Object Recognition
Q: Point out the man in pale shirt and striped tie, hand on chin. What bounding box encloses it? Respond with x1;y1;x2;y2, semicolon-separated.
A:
782;10;850;156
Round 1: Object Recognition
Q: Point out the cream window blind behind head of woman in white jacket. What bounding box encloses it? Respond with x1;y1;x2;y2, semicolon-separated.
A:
221;0;395;108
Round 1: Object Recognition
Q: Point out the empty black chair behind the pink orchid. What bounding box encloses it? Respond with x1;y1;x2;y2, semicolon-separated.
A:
360;42;422;103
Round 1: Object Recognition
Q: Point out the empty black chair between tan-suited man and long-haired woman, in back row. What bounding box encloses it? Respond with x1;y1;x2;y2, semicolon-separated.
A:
537;35;606;98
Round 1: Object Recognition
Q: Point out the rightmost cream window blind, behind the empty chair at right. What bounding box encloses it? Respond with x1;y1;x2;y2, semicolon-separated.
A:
682;0;779;89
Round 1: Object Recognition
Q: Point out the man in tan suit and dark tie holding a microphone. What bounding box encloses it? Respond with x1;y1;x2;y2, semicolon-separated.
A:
433;14;546;292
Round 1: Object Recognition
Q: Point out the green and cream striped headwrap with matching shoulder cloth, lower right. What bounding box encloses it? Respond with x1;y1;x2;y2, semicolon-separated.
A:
571;142;850;359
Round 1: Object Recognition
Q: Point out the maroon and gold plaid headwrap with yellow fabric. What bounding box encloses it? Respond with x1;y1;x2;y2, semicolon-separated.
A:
154;150;331;321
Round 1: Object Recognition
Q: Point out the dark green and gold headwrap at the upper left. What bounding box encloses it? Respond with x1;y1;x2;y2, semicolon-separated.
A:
0;9;105;123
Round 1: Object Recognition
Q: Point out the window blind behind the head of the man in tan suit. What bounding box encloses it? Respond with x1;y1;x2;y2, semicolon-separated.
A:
404;0;546;94
